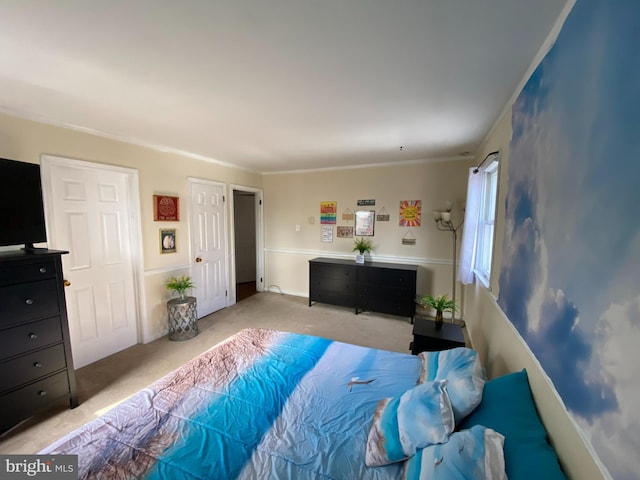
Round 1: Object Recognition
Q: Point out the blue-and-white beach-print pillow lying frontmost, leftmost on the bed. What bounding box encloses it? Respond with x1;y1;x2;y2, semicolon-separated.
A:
365;381;455;467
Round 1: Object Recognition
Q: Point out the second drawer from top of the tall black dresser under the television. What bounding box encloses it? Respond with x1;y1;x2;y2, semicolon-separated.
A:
0;279;60;328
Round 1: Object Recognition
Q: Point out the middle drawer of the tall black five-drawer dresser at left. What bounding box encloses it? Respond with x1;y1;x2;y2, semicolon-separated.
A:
0;317;62;360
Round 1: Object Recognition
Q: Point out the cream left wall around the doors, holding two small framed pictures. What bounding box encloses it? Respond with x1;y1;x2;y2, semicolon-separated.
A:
0;114;262;342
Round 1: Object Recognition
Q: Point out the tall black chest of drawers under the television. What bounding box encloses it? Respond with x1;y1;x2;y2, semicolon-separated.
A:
0;250;78;432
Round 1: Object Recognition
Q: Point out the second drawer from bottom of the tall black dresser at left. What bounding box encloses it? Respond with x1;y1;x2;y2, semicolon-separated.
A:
0;344;67;391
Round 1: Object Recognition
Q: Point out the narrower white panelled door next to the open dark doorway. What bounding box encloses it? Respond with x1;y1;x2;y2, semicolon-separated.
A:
189;178;227;317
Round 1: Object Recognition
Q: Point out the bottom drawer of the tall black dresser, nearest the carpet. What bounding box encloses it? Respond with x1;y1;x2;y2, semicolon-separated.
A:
0;372;69;431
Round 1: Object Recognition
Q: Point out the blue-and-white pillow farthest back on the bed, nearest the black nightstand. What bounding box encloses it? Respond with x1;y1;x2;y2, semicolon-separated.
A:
418;347;487;424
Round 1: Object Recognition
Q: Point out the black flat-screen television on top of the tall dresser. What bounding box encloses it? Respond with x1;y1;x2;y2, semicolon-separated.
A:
0;158;47;252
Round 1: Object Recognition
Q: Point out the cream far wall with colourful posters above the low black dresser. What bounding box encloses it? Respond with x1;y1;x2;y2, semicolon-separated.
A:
263;160;473;304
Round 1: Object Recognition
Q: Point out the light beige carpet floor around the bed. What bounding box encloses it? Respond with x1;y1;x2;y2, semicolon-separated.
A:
0;292;412;454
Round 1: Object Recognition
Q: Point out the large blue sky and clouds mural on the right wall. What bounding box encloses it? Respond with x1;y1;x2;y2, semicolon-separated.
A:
498;0;640;480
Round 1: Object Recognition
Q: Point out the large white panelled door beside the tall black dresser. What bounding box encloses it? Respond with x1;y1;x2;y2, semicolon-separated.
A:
43;157;138;368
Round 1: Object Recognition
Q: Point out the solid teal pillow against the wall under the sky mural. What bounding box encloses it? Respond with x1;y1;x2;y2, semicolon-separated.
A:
459;370;566;480
